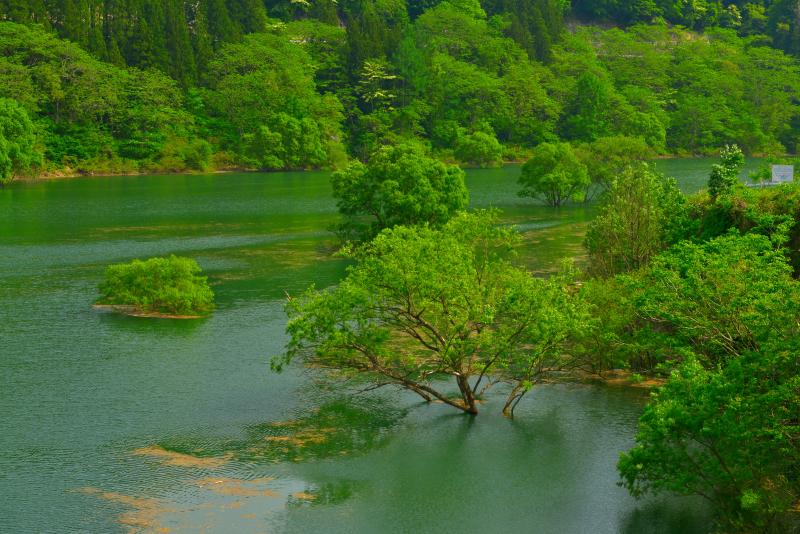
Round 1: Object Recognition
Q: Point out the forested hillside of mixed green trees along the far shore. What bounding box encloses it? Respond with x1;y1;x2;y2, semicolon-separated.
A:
0;0;800;180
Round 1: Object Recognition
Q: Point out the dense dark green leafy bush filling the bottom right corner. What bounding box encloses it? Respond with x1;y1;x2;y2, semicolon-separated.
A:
619;350;800;533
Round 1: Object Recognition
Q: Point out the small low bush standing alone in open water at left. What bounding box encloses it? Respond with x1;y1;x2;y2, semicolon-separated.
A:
95;255;214;319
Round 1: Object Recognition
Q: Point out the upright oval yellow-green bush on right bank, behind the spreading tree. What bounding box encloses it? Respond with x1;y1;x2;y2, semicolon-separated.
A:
585;164;686;277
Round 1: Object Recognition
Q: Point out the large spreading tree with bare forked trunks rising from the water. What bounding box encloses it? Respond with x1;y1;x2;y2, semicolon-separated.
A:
273;213;585;415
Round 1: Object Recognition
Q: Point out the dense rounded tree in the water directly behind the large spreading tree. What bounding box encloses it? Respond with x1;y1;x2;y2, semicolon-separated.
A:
331;145;469;240
